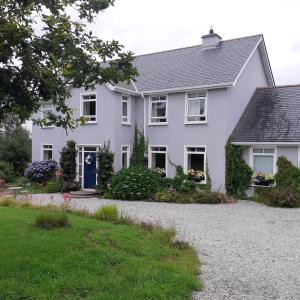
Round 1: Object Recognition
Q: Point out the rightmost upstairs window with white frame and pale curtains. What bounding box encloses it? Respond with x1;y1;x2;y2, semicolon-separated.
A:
185;92;207;124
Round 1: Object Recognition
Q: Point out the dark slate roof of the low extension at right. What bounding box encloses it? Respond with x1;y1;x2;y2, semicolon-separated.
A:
230;85;300;143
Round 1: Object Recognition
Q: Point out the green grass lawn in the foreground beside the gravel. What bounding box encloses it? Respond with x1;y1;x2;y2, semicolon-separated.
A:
0;207;200;300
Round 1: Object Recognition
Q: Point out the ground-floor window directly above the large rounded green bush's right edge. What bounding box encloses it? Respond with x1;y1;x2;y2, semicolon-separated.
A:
149;146;167;177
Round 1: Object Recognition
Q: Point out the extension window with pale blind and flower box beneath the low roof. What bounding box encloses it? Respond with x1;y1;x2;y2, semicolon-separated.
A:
252;147;276;186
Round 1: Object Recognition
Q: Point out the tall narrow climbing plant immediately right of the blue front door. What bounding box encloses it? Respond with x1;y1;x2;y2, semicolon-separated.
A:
97;143;114;194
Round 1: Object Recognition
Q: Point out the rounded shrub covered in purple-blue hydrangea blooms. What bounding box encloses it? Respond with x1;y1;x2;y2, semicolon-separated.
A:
24;160;58;184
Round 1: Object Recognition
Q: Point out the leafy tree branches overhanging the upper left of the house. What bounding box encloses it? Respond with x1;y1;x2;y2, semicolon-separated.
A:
0;0;137;129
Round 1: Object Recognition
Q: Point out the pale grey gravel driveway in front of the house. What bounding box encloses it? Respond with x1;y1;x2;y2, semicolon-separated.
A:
28;196;300;300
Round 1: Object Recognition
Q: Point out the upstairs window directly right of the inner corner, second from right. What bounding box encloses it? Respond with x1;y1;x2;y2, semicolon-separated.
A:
149;96;168;125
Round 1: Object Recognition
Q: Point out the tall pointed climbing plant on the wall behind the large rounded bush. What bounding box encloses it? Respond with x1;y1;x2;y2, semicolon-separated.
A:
130;125;148;167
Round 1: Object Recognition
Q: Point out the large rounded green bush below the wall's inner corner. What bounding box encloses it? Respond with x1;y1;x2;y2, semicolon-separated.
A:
111;166;160;200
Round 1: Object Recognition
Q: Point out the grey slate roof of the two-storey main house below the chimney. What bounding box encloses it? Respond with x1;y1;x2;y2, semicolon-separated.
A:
119;35;262;92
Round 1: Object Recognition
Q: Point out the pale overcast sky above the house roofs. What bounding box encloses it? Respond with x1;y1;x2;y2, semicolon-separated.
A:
87;0;300;85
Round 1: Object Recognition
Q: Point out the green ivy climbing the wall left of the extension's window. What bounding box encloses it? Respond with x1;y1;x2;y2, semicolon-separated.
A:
225;142;253;198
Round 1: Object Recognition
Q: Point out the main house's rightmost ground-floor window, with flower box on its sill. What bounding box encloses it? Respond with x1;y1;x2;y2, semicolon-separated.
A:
184;146;206;183
